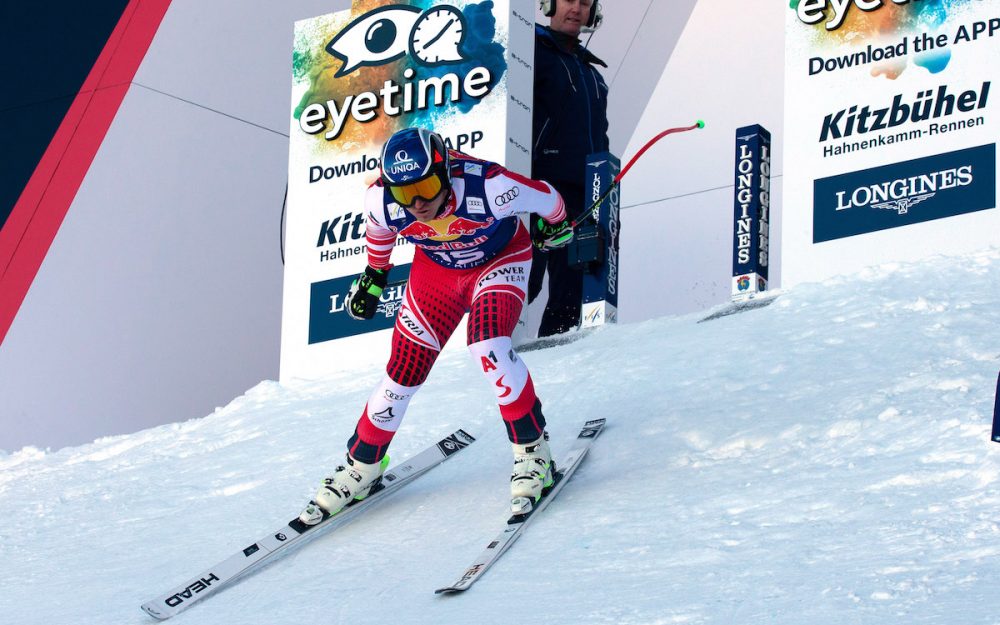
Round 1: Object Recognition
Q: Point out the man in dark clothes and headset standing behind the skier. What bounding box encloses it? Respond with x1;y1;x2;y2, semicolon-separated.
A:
528;0;608;337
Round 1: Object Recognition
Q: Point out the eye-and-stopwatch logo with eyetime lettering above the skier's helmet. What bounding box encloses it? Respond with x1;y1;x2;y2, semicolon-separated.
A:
299;4;493;141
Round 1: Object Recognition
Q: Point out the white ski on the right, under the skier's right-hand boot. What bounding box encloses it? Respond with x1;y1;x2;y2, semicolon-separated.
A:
434;419;605;595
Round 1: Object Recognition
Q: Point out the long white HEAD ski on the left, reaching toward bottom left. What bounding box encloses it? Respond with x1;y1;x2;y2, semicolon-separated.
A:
142;430;476;621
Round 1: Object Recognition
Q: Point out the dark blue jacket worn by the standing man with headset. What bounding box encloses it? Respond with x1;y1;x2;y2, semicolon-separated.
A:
531;24;608;193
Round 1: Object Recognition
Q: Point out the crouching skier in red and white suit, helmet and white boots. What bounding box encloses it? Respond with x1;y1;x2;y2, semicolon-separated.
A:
299;128;573;525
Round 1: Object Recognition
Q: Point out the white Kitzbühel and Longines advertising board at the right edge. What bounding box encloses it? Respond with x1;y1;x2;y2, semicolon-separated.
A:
781;0;1000;286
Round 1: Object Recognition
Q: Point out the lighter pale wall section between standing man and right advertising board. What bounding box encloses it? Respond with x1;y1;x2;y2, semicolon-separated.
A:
619;0;785;322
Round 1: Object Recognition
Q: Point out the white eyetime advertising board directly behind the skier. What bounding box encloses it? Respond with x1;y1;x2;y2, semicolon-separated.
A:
281;0;534;379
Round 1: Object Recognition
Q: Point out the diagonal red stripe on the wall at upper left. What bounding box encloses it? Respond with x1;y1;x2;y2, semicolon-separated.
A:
0;0;170;343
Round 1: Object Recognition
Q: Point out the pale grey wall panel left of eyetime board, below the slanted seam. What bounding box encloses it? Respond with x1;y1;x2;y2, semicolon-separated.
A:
0;89;286;450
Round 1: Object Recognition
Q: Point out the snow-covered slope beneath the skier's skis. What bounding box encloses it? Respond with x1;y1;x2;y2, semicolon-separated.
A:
0;248;1000;625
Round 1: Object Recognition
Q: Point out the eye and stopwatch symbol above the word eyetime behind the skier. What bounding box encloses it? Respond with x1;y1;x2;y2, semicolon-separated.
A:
326;4;466;78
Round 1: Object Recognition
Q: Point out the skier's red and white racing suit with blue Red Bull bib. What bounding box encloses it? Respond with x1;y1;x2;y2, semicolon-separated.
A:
348;151;566;463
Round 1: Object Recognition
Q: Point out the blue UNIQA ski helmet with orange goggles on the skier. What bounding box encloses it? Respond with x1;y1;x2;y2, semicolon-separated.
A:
382;128;451;206
